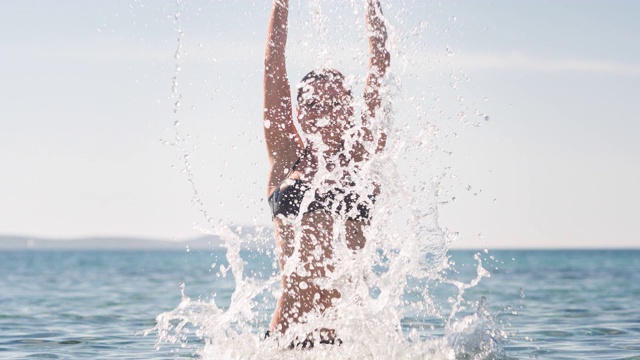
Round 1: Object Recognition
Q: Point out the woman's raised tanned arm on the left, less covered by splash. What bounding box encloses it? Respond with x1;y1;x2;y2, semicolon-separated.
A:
263;0;303;193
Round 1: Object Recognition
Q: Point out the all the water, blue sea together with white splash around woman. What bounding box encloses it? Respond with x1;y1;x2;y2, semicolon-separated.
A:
5;1;640;359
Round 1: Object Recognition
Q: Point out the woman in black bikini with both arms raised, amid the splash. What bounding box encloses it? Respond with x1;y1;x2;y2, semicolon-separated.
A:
264;0;389;346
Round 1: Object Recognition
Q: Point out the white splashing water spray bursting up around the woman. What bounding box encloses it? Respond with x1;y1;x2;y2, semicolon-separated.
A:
149;0;504;359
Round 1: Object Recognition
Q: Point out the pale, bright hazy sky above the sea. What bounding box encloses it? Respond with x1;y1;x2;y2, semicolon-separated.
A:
0;0;640;248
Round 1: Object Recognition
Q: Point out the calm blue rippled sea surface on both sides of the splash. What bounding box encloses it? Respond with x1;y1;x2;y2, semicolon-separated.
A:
0;250;640;359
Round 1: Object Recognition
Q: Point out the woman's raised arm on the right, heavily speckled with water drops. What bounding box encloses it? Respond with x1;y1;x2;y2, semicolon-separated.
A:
363;0;391;152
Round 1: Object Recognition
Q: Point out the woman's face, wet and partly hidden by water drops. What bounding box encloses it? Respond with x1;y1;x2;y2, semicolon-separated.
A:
298;79;353;146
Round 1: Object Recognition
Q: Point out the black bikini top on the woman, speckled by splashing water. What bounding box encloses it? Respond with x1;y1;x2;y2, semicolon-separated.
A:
269;151;375;221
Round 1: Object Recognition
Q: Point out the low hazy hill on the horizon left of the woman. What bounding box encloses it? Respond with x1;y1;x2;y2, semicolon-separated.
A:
0;228;273;251
